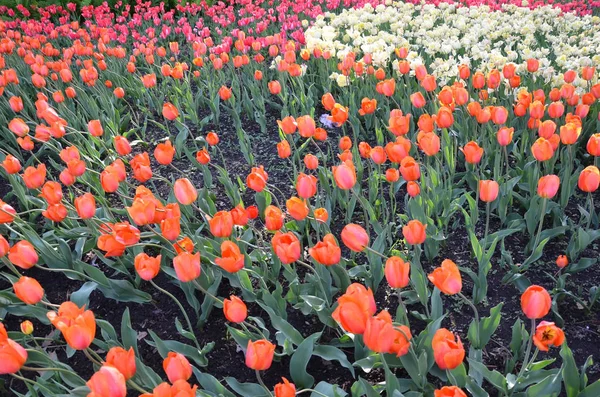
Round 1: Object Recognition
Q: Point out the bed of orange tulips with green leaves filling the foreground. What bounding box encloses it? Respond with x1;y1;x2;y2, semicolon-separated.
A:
0;2;600;397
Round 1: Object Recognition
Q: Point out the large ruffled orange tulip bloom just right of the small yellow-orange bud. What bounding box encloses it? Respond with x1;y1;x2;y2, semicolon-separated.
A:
47;302;96;350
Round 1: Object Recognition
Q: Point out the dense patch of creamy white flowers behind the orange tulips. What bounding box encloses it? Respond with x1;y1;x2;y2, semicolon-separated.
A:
305;2;600;87
